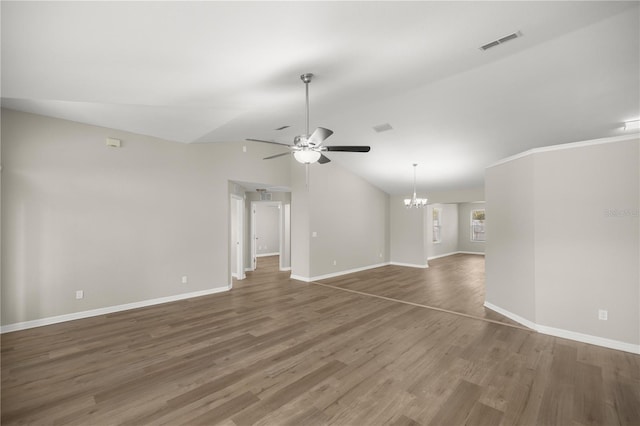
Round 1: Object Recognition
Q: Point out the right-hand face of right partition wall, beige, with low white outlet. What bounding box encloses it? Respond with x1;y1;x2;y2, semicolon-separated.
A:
534;140;640;344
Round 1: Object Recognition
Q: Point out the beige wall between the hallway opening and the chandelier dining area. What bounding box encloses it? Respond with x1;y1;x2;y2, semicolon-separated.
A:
291;162;389;279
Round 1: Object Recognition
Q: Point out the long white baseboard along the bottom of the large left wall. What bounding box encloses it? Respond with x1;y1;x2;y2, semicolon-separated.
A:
0;286;231;334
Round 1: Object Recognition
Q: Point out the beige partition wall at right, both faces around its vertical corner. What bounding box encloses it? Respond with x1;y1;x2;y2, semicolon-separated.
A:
486;137;640;350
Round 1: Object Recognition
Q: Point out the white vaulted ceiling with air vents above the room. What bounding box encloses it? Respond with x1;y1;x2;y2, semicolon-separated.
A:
1;1;640;195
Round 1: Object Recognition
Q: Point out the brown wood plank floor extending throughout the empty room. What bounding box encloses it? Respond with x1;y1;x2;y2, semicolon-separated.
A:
1;256;640;426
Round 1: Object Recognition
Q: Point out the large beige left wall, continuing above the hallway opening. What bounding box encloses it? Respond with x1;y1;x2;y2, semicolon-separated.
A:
2;109;290;325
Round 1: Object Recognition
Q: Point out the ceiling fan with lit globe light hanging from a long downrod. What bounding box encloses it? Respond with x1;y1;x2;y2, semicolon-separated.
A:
247;73;371;164
